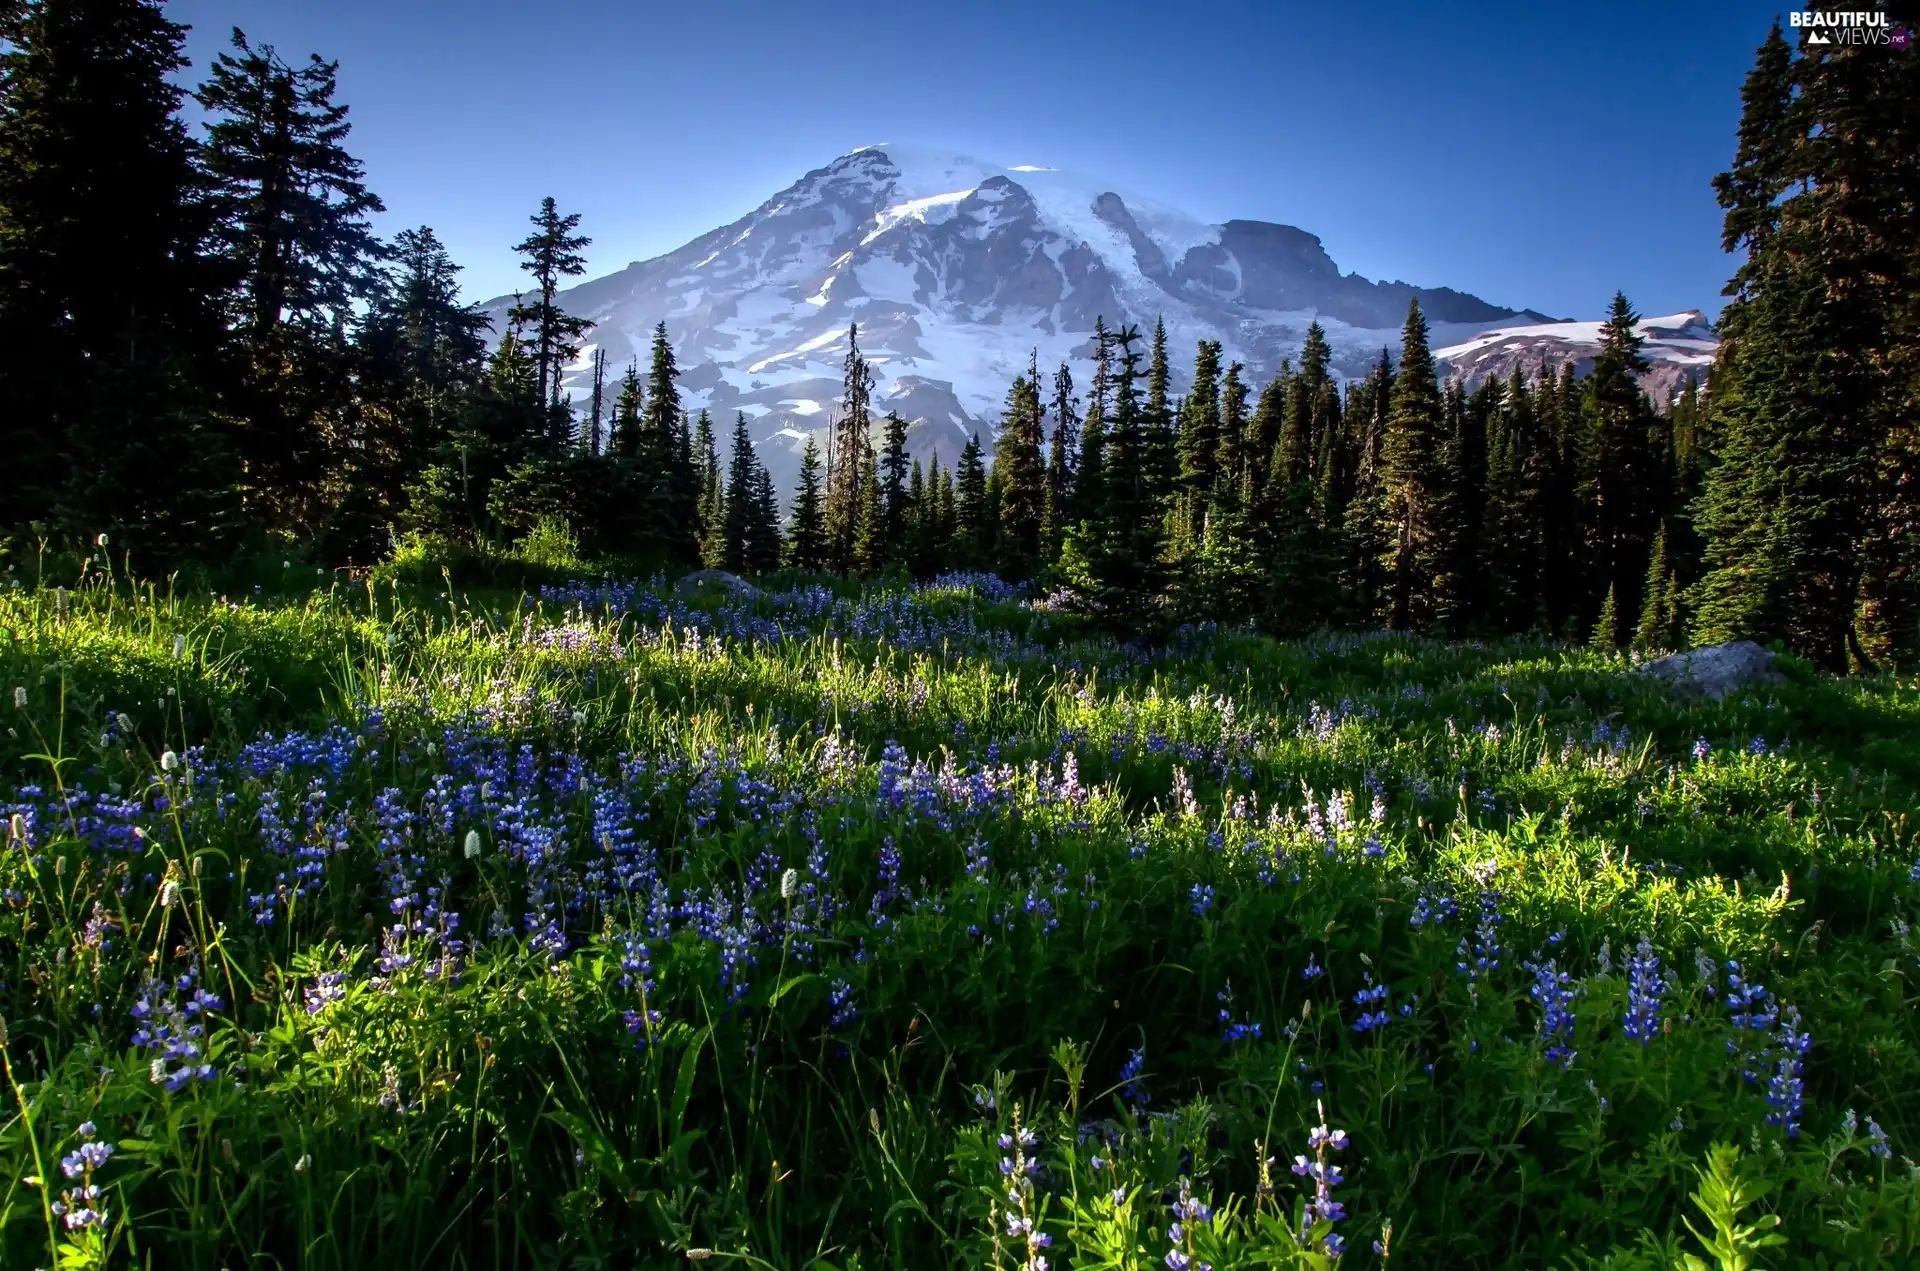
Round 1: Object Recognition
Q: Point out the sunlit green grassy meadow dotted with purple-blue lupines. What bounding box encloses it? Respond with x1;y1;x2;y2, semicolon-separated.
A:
0;553;1920;1271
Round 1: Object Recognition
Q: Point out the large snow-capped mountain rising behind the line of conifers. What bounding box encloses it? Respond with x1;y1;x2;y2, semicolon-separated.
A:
488;144;1711;490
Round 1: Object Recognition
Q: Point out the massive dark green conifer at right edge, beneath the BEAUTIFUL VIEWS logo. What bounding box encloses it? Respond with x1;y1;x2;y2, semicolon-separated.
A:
1692;25;1920;670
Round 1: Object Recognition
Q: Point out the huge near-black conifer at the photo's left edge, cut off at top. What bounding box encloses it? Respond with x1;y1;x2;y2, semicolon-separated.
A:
0;0;240;563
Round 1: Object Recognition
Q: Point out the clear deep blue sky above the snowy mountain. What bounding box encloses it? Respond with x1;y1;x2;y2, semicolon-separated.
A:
167;0;1774;317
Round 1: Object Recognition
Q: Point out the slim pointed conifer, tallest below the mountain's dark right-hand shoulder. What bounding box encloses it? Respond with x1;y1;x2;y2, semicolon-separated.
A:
1380;300;1446;632
